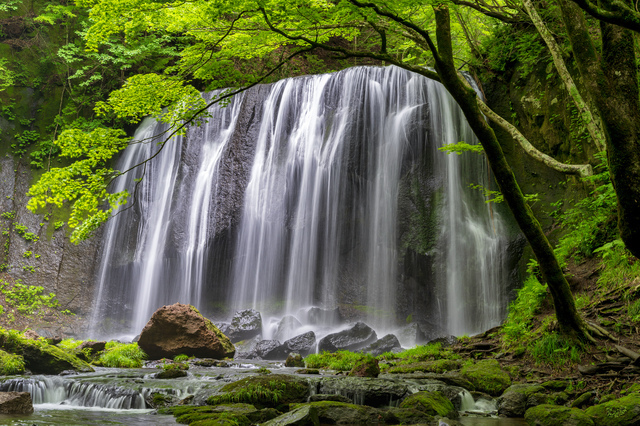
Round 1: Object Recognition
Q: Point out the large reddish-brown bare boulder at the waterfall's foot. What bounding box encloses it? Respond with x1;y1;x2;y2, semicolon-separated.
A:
138;303;235;359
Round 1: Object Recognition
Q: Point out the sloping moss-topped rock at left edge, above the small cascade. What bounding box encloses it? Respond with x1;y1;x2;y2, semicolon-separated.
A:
0;330;93;374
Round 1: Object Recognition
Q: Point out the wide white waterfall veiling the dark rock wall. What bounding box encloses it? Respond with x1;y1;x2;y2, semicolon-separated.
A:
92;67;510;335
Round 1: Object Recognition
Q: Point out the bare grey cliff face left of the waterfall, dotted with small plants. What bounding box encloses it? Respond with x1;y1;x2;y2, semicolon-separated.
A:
0;154;99;333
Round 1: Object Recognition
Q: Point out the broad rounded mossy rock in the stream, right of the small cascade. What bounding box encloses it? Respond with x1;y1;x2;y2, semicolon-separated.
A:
207;374;309;408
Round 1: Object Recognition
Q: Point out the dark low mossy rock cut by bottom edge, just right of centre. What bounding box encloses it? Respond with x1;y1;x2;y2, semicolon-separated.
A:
291;401;394;425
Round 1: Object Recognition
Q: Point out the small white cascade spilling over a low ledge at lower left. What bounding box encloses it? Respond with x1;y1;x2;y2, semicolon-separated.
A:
0;376;146;410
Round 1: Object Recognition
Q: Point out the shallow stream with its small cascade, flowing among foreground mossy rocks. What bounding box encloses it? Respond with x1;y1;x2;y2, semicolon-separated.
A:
0;360;526;426
